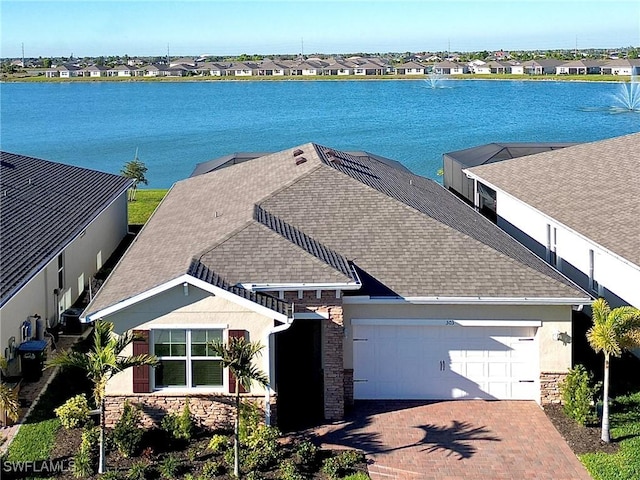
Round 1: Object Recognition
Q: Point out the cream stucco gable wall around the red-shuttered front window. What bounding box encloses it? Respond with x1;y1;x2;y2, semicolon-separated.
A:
103;286;274;395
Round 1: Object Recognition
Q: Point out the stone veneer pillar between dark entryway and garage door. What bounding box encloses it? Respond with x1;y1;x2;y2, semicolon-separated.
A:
284;290;345;420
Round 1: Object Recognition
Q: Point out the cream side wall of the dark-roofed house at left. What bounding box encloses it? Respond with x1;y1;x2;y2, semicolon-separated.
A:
0;192;128;360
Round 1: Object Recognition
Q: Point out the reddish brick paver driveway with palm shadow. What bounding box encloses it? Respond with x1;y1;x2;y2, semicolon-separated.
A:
314;400;591;480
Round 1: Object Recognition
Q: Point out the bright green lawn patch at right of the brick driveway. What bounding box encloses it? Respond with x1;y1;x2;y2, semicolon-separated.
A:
579;392;640;480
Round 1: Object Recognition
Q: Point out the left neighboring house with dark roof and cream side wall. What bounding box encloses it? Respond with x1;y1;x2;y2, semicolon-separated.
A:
0;152;131;373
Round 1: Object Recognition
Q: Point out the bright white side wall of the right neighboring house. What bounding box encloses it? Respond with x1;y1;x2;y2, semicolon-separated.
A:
496;190;640;308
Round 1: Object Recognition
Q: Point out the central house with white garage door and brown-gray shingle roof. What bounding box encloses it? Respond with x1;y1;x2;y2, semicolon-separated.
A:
83;143;591;428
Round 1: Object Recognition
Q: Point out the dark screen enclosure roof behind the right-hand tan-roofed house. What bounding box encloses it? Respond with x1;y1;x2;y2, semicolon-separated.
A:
445;142;577;167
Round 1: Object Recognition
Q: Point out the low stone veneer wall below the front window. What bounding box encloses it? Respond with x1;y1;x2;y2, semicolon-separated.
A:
105;393;266;430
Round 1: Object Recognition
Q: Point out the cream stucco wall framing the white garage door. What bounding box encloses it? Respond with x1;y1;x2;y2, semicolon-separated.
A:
343;304;571;373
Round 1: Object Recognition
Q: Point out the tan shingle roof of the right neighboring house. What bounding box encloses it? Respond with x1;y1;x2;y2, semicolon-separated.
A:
470;133;640;265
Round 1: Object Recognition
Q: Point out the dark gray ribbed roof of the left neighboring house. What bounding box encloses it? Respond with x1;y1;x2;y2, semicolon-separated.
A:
0;152;131;305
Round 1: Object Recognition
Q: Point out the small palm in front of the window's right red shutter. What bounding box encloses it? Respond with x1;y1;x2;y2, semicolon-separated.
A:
212;337;269;478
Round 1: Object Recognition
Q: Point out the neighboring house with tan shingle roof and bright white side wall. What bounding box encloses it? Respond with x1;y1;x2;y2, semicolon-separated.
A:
465;134;640;308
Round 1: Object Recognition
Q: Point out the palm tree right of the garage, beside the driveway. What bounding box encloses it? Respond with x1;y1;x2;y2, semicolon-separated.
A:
587;298;640;443
